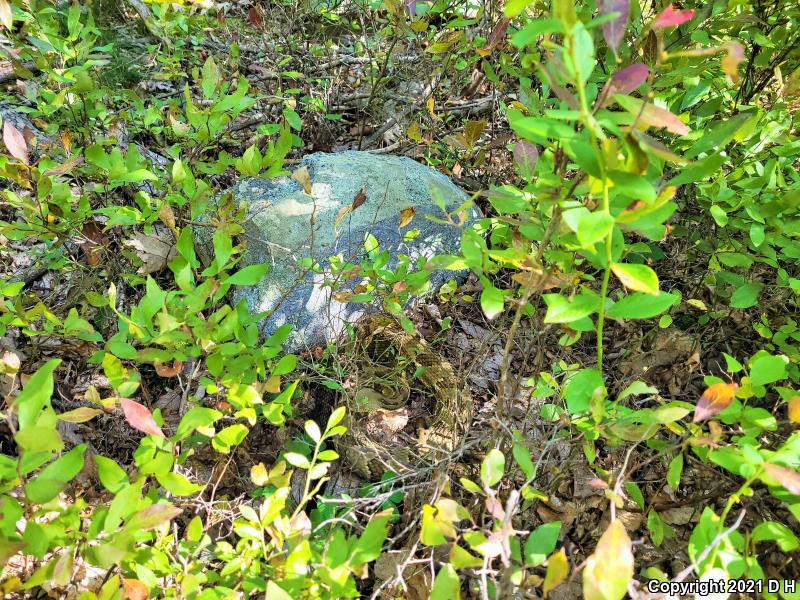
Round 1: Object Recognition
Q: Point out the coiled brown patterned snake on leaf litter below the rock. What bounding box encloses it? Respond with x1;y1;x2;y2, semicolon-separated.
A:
337;315;473;480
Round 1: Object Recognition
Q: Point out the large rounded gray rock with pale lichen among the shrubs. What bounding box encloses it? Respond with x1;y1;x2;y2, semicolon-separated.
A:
206;151;480;351
